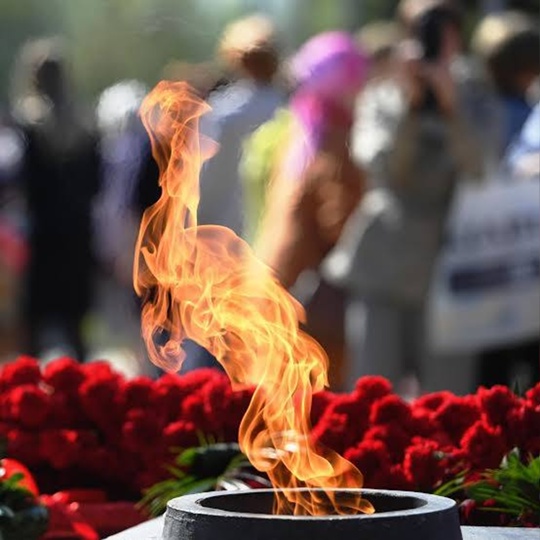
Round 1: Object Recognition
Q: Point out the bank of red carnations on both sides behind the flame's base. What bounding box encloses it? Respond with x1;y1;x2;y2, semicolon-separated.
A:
0;357;540;524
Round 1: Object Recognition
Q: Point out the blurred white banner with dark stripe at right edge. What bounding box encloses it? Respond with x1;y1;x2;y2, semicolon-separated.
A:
428;180;540;352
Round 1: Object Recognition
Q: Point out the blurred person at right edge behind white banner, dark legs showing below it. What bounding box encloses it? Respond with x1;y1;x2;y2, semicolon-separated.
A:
472;11;540;387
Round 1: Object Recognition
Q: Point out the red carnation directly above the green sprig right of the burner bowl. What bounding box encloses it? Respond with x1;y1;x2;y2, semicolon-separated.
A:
461;420;508;469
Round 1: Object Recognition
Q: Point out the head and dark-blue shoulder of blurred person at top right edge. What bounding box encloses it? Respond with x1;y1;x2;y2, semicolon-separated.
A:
472;11;540;155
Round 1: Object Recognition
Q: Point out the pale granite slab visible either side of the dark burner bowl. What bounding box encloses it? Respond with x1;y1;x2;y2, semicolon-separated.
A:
105;518;540;540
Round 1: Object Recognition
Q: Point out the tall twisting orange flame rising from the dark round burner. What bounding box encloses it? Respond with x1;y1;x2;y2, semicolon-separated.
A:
134;81;373;515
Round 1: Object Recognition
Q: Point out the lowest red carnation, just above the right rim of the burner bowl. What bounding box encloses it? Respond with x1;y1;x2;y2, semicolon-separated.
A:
403;439;444;491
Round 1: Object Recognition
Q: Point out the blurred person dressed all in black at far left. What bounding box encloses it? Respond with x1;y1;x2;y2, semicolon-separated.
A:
13;39;100;361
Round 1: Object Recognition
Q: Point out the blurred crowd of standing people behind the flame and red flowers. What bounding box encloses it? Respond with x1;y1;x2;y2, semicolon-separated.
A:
0;0;540;396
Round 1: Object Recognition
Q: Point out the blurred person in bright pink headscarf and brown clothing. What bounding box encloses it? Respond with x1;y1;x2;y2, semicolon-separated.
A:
248;31;368;389
